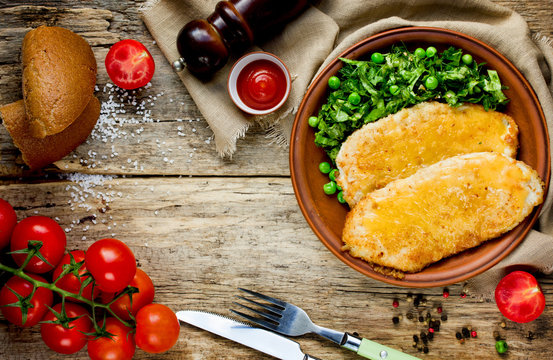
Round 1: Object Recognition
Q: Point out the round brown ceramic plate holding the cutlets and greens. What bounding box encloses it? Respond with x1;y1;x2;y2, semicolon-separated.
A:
290;27;551;287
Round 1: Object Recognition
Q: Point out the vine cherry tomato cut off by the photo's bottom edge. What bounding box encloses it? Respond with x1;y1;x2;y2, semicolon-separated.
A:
88;317;136;360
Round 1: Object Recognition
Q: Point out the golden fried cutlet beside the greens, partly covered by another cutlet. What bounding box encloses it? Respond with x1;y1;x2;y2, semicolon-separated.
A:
336;102;518;207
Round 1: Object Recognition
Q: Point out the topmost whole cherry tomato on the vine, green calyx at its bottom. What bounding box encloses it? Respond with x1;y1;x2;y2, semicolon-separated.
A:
10;216;67;274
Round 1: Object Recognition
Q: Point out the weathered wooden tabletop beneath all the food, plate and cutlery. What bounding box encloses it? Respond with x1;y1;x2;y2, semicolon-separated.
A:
0;0;553;359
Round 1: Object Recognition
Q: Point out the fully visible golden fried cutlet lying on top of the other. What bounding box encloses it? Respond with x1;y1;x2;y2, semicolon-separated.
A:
342;152;543;272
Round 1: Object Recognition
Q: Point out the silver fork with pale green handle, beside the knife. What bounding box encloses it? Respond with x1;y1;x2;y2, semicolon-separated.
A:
230;288;420;360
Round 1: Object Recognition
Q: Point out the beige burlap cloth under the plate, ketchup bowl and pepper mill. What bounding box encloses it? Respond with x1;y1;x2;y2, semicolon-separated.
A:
143;0;553;297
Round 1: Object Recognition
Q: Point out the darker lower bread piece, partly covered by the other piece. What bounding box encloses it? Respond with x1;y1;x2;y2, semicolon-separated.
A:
0;96;100;169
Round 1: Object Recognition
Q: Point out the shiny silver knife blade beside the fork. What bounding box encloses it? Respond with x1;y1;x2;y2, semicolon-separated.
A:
177;310;320;360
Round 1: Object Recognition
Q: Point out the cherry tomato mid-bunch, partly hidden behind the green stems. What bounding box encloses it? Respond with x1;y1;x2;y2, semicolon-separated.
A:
52;250;100;302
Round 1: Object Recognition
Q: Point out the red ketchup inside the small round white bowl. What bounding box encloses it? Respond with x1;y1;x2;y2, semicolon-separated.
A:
236;59;286;110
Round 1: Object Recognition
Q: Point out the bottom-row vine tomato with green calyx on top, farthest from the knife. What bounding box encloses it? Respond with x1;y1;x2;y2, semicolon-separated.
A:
40;302;92;354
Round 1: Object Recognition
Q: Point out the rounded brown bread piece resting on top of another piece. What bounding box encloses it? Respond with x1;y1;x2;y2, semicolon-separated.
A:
22;26;97;138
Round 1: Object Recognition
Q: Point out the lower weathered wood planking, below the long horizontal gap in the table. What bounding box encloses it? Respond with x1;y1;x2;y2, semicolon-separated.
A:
0;177;553;359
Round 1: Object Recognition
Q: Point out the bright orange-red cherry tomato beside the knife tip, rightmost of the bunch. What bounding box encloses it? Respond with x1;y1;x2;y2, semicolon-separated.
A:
134;304;180;354
